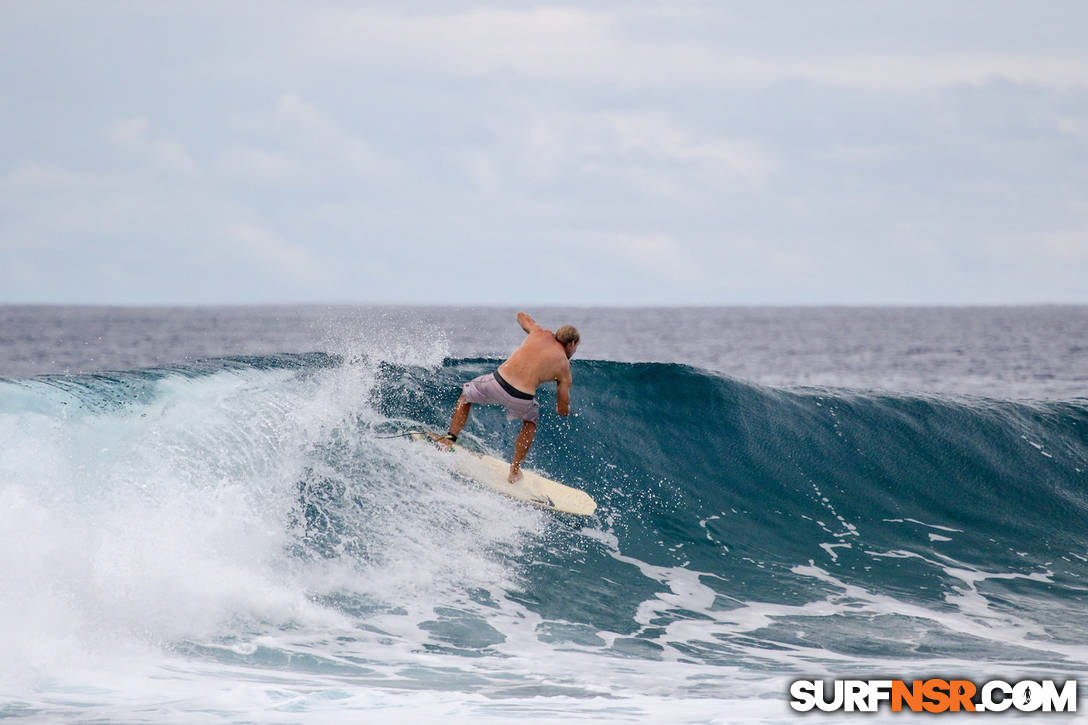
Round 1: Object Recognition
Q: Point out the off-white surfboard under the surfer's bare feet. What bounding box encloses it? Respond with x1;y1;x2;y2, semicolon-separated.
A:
411;430;597;516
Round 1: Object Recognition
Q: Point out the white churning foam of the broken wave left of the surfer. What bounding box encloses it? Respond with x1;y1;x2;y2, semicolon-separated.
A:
0;348;542;696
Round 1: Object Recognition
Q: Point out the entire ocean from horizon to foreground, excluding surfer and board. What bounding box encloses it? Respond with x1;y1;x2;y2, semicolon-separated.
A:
0;307;1088;723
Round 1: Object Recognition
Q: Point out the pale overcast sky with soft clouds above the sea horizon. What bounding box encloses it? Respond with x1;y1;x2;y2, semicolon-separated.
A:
0;0;1088;306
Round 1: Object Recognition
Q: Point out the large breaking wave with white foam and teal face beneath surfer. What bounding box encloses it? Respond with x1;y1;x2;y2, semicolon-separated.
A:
0;354;1088;709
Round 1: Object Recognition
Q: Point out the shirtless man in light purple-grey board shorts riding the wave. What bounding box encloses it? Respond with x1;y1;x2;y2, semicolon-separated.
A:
438;312;579;483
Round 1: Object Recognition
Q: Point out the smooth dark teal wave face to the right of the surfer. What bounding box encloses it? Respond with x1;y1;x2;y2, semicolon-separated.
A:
379;360;1088;666
